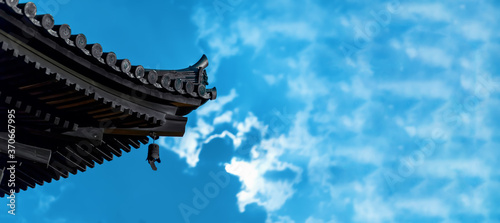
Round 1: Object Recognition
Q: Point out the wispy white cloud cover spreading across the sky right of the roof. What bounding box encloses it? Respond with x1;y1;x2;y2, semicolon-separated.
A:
182;0;498;223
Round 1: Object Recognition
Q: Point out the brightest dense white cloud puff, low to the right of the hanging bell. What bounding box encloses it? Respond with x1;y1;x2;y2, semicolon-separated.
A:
226;113;302;212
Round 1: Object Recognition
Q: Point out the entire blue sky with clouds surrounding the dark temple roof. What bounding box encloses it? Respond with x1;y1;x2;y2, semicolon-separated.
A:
0;0;500;223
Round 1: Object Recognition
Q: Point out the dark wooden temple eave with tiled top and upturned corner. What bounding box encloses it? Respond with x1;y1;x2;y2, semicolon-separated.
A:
0;0;217;197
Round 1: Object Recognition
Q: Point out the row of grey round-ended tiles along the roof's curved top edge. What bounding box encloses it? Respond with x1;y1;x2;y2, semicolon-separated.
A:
0;0;217;100
